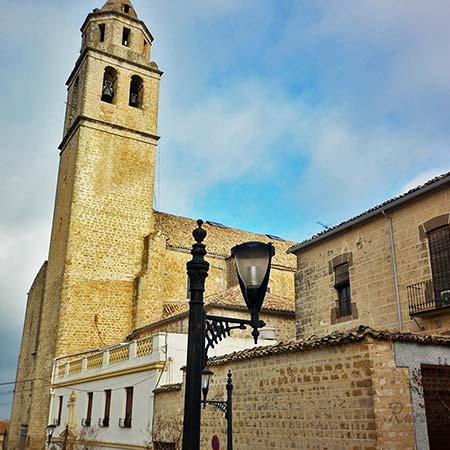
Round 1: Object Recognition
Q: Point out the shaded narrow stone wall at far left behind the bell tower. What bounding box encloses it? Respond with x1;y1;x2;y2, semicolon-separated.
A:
8;263;47;449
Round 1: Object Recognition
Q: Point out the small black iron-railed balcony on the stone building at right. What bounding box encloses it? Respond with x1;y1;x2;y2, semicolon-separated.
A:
406;280;450;316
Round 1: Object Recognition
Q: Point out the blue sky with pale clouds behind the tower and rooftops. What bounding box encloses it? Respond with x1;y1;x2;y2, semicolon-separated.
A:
0;0;450;419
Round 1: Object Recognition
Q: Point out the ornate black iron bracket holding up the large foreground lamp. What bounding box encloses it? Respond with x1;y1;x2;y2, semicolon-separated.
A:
205;314;266;365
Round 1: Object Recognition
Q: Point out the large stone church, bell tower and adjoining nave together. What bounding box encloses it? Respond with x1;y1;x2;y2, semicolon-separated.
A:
9;0;295;450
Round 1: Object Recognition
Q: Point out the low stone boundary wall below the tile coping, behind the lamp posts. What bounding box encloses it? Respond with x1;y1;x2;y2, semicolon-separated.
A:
155;338;415;450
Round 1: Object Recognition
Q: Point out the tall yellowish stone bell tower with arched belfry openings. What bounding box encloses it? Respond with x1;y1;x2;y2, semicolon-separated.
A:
9;0;162;450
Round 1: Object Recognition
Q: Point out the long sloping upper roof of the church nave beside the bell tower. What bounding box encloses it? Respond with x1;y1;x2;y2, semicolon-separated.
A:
154;211;295;269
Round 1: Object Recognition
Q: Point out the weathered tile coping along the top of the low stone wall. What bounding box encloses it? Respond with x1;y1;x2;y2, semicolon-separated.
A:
208;325;450;366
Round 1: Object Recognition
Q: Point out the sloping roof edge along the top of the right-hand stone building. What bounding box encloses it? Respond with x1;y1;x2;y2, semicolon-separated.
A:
287;172;450;253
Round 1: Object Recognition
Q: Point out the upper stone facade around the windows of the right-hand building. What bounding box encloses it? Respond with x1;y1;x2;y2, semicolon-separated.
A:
295;188;450;337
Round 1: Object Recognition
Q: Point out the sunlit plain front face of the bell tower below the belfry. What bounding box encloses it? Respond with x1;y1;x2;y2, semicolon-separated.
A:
57;126;155;354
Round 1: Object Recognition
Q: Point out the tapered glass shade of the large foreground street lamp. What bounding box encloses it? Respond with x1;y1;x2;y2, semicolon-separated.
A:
231;242;273;289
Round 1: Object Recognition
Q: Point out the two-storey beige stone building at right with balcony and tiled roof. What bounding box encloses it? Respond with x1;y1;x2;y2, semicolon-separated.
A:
289;173;450;338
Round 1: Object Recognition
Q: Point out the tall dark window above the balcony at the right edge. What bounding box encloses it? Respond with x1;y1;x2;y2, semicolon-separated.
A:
428;226;450;299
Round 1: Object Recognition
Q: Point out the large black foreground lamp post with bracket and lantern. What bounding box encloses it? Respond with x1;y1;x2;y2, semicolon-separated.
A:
182;220;275;450
